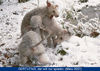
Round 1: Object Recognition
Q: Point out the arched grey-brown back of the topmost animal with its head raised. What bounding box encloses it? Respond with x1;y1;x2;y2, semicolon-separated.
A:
21;7;45;36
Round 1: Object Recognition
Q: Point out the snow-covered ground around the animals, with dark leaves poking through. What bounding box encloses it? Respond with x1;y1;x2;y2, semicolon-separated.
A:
0;0;100;67
